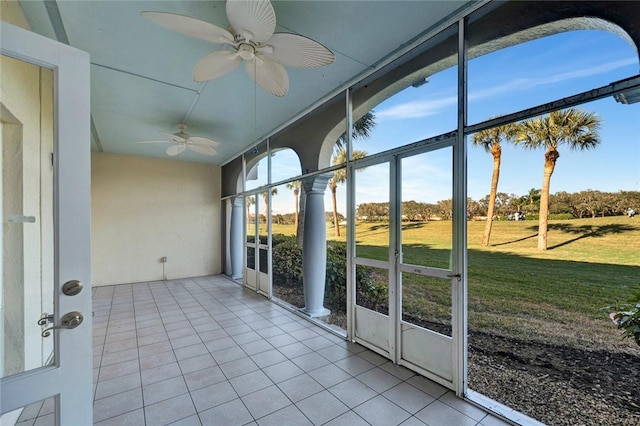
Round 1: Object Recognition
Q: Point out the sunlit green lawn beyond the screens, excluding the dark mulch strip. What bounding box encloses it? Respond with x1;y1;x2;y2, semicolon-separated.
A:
273;216;640;351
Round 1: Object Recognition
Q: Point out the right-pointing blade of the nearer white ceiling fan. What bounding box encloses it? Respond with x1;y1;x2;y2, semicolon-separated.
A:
258;33;336;68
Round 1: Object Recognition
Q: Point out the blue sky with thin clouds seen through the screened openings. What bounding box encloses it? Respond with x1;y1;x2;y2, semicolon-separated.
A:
252;31;640;213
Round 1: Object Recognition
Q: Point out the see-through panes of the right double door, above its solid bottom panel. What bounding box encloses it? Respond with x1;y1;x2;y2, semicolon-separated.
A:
400;147;453;336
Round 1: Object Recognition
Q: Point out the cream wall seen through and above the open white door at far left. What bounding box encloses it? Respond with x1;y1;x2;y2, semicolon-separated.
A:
0;2;53;380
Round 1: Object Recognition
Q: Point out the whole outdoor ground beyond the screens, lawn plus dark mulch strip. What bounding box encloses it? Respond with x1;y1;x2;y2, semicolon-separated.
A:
273;216;640;425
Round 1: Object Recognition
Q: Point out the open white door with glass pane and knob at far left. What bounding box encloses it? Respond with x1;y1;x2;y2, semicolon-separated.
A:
0;22;93;425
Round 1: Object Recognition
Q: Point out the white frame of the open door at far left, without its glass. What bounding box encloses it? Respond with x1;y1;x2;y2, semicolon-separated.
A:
0;22;93;425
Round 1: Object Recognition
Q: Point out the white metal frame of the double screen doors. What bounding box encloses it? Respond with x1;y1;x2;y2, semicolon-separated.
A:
347;132;466;391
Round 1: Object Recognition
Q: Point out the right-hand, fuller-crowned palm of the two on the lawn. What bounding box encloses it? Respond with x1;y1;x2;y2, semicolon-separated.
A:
516;108;602;250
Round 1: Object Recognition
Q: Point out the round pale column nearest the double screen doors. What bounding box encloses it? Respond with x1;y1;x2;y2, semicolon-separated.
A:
301;174;331;317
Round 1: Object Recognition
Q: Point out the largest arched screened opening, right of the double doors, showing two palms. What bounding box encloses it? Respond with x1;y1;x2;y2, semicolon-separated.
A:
467;18;640;424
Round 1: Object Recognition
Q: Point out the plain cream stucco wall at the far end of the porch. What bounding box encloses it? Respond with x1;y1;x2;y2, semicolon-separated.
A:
91;153;222;286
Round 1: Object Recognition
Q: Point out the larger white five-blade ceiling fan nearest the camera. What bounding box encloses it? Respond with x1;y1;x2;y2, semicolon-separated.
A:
142;0;335;96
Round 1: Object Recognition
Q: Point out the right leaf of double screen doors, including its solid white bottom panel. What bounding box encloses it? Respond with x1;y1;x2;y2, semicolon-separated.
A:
396;146;453;386
